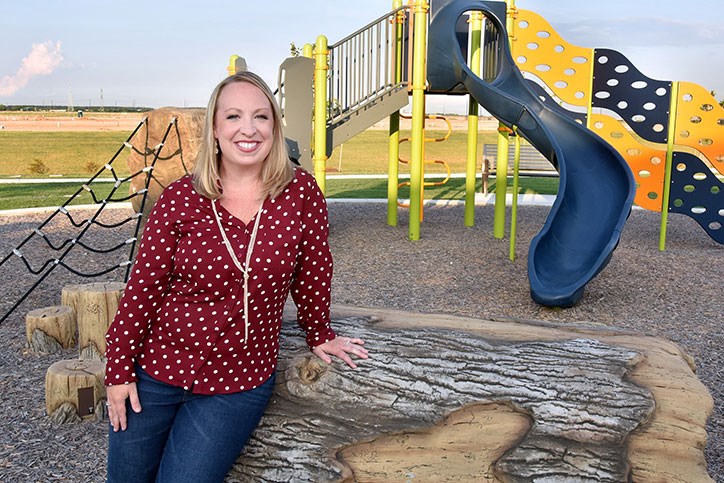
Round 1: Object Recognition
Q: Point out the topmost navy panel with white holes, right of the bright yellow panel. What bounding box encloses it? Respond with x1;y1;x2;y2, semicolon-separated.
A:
592;49;671;143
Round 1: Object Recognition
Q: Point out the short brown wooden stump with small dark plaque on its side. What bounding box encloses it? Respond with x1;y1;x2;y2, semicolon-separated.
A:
45;359;106;423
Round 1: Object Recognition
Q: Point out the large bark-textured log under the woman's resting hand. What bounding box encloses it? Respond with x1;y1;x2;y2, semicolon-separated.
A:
230;307;712;482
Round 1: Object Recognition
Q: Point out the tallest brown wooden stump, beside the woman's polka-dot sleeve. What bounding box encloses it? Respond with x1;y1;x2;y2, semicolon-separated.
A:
61;282;126;359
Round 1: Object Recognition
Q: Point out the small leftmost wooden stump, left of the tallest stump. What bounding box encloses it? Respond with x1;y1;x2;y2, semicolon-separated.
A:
25;305;77;354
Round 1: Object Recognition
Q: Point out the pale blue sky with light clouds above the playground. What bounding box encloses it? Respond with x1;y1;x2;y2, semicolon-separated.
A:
0;0;724;112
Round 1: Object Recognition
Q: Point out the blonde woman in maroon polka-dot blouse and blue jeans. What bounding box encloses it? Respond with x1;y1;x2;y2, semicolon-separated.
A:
105;72;367;483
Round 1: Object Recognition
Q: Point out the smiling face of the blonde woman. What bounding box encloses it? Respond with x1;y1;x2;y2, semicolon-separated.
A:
214;82;274;178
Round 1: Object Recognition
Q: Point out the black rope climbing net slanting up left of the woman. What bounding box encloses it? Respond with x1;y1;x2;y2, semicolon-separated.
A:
0;117;189;324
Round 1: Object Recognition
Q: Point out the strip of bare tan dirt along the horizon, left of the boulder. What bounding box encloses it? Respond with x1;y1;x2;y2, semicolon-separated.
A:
0;112;144;131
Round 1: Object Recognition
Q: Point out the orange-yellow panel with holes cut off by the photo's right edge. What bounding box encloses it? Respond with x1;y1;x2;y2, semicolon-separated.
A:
674;82;724;174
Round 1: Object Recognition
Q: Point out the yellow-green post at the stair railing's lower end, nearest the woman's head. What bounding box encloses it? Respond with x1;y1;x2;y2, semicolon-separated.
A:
312;35;329;193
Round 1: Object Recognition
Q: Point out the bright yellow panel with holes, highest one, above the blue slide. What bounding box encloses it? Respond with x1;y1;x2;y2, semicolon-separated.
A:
511;10;593;106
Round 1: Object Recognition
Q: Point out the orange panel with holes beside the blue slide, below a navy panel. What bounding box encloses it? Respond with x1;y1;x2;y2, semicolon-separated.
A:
591;114;666;211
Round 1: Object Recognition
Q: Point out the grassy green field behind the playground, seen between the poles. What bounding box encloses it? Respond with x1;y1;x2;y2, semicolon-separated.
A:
0;130;558;209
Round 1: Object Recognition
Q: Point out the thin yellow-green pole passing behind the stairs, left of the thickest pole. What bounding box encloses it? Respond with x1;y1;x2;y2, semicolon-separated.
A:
387;0;405;226
